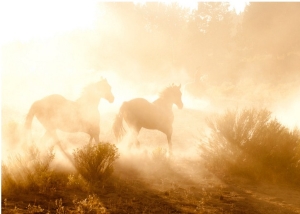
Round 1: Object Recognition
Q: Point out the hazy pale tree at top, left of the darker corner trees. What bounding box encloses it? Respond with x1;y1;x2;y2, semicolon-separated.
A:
187;2;237;82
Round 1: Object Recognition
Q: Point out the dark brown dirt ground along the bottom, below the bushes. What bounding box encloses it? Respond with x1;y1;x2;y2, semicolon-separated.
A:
2;154;300;214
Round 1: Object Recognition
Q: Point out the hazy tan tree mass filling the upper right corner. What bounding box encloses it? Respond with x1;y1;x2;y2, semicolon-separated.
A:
235;2;300;84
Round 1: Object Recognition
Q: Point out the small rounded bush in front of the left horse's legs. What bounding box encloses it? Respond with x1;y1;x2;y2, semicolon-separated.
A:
73;143;119;184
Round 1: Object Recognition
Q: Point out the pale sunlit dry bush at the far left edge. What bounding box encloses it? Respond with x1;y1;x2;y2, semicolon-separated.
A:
1;145;57;194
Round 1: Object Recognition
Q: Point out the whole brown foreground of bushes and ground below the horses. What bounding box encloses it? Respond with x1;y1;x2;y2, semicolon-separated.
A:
2;109;300;213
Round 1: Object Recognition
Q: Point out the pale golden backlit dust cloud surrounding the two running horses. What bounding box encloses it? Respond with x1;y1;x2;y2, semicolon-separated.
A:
1;3;300;181
